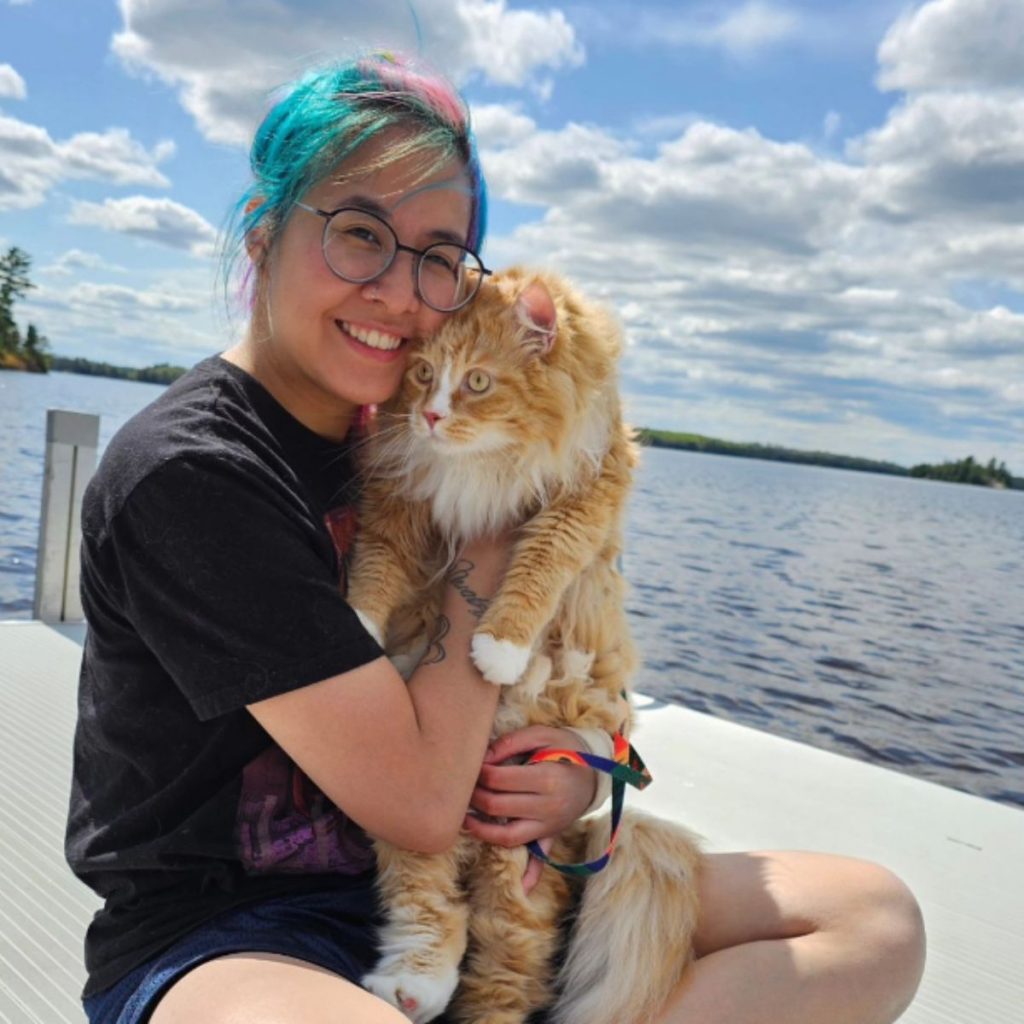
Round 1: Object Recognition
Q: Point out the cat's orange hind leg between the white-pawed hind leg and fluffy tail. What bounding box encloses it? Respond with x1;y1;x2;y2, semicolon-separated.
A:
451;844;571;1024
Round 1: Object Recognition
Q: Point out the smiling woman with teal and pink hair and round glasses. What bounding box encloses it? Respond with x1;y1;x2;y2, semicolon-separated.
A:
68;54;923;1024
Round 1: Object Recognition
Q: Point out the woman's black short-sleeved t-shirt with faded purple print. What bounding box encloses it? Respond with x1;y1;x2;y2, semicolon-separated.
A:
67;357;382;994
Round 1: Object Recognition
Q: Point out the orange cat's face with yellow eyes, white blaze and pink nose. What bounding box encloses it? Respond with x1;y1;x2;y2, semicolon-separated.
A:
396;272;558;455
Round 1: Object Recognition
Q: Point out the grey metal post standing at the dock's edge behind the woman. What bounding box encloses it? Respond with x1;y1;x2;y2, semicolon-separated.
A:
33;409;99;623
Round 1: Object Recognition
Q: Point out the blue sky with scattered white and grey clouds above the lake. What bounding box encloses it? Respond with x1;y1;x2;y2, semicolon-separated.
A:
0;0;1024;475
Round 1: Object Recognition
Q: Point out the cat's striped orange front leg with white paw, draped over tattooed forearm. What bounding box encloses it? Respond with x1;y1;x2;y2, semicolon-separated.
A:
471;449;632;685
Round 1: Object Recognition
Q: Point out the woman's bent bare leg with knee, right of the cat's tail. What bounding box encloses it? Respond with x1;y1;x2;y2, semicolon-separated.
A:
659;853;925;1024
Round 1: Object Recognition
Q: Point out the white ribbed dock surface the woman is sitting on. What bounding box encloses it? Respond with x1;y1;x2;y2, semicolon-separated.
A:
0;622;1024;1024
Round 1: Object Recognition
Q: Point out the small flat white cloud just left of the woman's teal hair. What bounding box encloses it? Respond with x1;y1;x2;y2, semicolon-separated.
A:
69;196;217;257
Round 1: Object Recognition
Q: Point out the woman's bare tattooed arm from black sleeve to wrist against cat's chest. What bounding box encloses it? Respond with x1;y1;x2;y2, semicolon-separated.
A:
249;540;508;853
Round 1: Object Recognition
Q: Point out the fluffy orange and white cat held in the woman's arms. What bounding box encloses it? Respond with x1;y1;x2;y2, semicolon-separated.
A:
349;268;698;1024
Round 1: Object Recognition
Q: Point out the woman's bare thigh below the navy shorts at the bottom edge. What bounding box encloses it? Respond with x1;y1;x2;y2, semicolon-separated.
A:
150;953;409;1024
